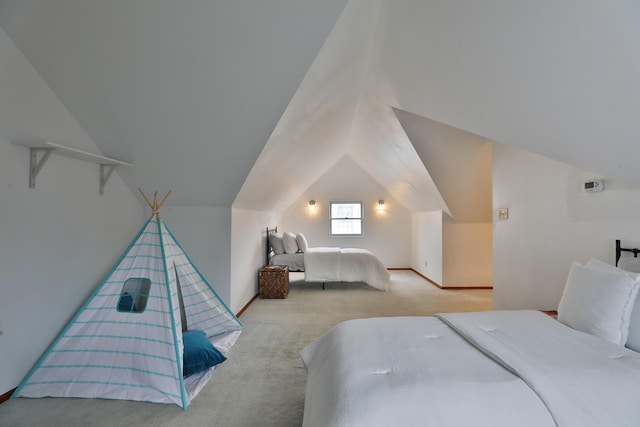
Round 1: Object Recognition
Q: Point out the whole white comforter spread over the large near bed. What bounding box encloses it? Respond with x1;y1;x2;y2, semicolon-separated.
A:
301;311;640;427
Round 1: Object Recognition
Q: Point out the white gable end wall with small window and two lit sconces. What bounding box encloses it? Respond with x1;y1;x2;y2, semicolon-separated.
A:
273;156;411;268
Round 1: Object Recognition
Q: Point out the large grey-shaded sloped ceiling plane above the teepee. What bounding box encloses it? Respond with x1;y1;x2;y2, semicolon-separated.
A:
0;0;347;207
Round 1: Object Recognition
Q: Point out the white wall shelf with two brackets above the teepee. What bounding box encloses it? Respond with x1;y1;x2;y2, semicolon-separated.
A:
13;140;133;194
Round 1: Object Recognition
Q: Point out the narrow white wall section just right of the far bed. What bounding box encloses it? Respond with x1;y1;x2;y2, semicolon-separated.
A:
411;211;443;285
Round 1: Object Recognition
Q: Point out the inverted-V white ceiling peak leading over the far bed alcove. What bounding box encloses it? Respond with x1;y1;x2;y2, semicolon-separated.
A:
234;0;450;214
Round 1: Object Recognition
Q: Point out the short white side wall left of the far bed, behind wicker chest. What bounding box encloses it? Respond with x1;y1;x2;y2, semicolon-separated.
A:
231;208;276;313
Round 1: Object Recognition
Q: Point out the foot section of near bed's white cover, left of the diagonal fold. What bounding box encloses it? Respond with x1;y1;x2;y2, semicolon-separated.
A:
301;317;555;427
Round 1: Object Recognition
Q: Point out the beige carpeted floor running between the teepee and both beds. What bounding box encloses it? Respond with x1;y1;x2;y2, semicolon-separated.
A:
0;270;493;427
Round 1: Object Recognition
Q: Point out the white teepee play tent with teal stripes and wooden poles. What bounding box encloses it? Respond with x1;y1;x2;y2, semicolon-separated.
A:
12;191;242;409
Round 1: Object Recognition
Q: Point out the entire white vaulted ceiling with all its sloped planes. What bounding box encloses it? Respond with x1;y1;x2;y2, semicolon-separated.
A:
0;0;640;222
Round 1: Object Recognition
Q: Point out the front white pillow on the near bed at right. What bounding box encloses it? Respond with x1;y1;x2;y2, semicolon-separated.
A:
558;262;640;345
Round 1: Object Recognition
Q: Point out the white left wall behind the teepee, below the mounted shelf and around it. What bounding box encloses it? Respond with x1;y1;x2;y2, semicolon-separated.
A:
0;25;144;394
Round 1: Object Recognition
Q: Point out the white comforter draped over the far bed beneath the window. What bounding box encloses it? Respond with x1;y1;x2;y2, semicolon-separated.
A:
304;247;390;291
